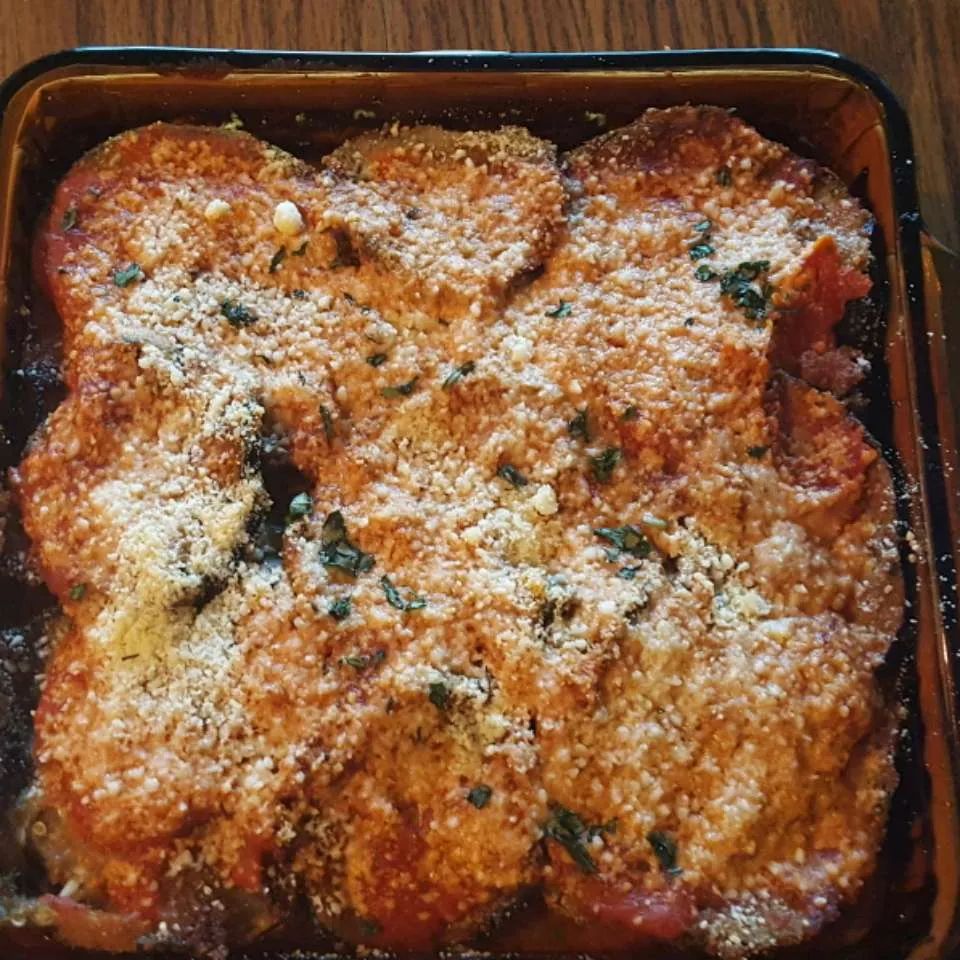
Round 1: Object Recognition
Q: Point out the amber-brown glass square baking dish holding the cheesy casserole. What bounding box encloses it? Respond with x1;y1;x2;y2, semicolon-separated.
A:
0;47;960;960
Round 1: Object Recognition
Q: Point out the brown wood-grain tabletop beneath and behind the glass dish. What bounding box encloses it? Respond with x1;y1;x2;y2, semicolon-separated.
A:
0;0;960;247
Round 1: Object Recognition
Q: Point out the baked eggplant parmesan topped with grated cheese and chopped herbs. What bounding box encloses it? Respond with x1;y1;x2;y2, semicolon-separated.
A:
1;107;903;958
